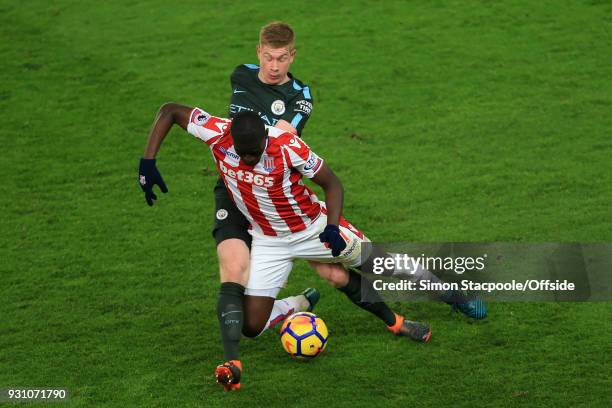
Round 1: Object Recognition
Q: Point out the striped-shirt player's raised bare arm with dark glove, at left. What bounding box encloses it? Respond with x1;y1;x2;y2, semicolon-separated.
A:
138;103;193;206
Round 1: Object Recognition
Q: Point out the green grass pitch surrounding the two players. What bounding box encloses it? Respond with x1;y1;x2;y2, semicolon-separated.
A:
0;0;612;407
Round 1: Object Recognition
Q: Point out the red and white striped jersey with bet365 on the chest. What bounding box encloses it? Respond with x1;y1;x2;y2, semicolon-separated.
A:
187;108;323;236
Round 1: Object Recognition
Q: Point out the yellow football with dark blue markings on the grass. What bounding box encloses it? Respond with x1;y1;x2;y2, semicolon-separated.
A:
281;312;328;359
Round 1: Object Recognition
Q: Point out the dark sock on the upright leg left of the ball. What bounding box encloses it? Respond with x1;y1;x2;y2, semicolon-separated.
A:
217;282;244;361
